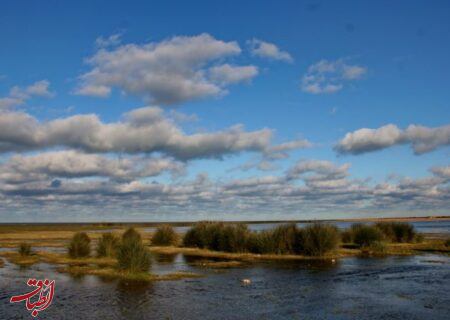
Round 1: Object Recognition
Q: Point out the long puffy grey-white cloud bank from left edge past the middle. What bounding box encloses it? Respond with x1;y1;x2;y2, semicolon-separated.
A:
0;107;278;160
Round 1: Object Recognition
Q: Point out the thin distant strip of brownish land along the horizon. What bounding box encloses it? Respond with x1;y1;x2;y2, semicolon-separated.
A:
0;216;450;227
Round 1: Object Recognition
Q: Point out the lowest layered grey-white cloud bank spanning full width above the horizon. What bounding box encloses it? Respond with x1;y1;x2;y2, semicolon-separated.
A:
0;153;450;220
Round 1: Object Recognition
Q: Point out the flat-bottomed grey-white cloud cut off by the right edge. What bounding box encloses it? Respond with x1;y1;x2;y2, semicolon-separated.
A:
335;124;450;154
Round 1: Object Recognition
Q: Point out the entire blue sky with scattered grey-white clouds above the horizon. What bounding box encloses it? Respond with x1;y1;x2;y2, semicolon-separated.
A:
0;1;450;222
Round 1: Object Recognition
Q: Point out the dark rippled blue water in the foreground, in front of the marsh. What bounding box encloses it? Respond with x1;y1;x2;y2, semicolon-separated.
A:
0;254;450;320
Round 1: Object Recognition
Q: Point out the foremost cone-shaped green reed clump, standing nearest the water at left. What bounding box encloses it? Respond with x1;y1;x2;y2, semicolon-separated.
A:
117;228;151;273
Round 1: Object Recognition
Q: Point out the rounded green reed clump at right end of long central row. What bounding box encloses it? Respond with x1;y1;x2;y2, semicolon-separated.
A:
300;223;340;256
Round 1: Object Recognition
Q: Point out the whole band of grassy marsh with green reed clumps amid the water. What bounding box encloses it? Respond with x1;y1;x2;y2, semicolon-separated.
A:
0;217;450;281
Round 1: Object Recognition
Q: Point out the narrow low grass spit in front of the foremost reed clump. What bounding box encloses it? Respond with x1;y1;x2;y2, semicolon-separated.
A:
57;266;201;281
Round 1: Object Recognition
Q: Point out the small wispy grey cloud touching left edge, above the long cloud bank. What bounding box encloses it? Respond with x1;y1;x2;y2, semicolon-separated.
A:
0;80;54;109
